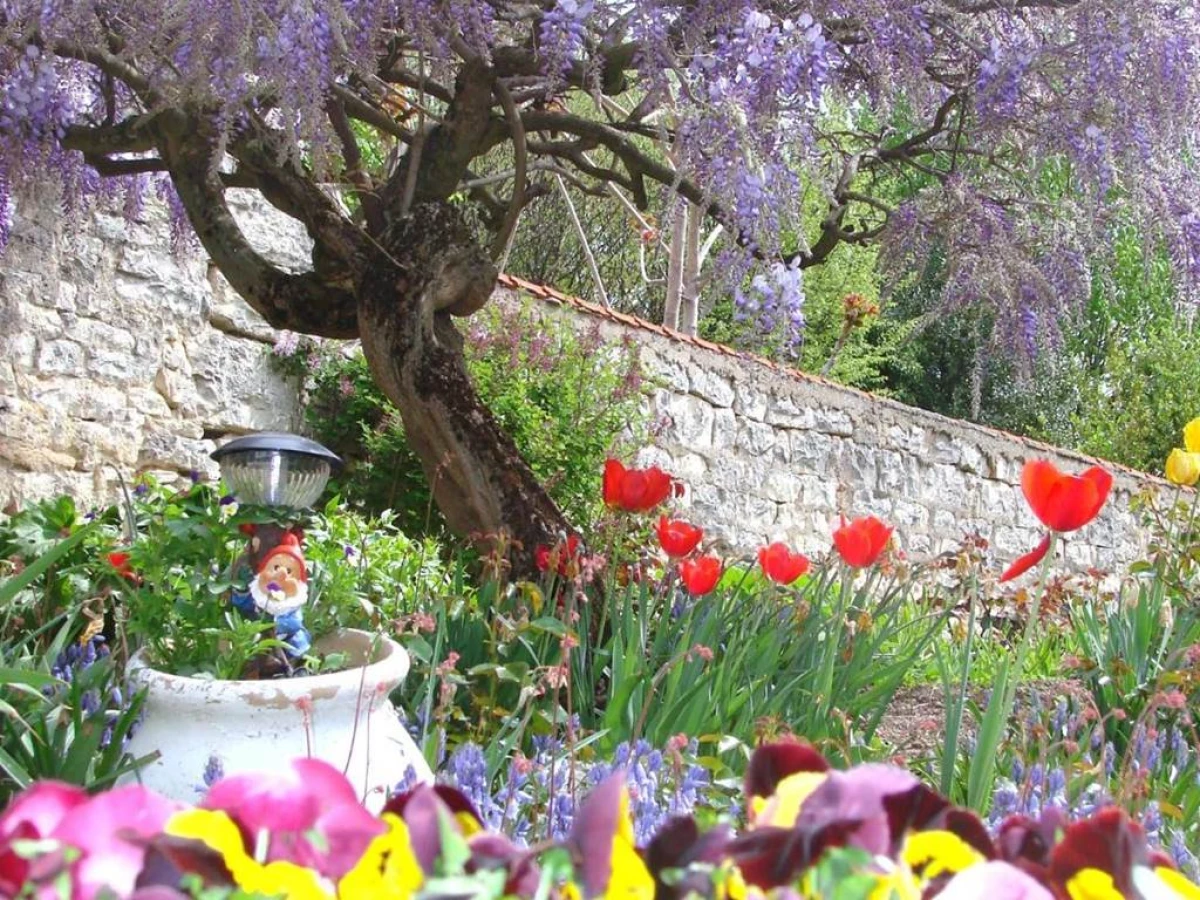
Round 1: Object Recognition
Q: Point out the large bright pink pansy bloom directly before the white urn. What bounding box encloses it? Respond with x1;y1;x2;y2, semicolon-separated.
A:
200;760;385;878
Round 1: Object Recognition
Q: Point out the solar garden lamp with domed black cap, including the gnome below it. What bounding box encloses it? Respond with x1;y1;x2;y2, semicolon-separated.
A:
212;432;342;670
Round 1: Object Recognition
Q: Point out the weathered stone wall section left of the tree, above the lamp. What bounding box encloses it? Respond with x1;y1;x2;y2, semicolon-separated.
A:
0;189;307;505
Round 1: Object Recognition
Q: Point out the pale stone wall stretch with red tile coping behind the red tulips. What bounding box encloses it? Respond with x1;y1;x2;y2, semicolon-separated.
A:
502;277;1163;571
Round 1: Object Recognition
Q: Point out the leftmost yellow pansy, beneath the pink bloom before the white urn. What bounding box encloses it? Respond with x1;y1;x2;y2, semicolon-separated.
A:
163;809;334;900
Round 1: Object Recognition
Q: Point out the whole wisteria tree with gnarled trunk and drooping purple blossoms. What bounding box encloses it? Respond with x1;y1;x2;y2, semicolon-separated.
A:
0;0;1200;552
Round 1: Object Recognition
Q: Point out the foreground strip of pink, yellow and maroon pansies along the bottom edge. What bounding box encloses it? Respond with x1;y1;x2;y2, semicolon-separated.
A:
0;743;1200;900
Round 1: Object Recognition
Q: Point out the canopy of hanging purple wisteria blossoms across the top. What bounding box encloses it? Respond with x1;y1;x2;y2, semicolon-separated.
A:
0;0;1200;352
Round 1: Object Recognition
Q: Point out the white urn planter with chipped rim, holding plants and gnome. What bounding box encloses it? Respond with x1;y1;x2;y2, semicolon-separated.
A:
121;630;432;812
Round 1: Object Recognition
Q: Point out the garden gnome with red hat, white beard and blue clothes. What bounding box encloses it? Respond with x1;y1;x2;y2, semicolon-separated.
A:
233;530;312;658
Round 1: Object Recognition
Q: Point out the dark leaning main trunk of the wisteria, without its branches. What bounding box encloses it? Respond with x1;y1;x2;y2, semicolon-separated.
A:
358;203;569;571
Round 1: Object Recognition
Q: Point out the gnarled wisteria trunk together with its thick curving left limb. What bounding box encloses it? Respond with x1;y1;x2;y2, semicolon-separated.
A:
157;110;569;574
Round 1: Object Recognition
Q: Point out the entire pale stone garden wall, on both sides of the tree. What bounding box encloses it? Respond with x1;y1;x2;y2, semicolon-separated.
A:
0;192;1166;578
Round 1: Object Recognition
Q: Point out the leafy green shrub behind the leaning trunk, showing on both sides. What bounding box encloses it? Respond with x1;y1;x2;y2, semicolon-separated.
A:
276;301;646;535
